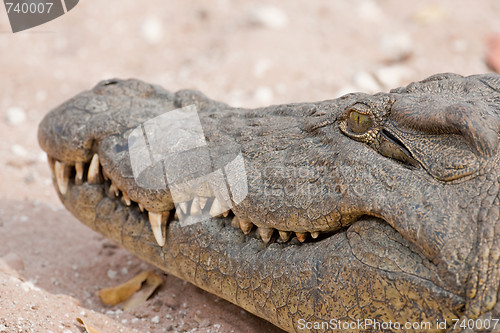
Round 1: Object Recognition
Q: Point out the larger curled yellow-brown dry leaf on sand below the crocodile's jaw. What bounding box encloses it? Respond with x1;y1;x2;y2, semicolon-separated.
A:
98;272;163;309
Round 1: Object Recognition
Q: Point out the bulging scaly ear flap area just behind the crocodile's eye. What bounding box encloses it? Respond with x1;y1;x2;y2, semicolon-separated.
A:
391;103;500;181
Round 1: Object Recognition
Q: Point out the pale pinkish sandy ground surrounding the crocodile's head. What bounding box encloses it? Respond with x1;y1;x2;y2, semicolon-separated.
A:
0;0;500;333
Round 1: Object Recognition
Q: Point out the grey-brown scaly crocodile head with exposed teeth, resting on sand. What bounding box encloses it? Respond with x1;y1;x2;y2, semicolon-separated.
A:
38;73;500;332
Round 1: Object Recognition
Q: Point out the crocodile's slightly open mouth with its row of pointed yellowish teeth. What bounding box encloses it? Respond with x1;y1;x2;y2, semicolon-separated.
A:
48;153;344;246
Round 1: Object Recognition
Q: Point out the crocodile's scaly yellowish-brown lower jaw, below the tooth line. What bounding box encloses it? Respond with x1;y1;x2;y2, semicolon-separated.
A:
45;154;464;331
